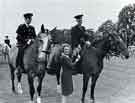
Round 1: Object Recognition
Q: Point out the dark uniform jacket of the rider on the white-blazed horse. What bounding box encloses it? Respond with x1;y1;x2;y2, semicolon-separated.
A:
16;24;36;45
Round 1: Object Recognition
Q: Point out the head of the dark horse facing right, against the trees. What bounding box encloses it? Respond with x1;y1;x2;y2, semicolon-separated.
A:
108;34;129;59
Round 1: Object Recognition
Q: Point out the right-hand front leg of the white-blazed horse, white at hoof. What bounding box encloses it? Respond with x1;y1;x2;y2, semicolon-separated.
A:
37;73;45;103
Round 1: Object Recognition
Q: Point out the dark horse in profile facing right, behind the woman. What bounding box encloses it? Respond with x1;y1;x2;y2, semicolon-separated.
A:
49;30;129;103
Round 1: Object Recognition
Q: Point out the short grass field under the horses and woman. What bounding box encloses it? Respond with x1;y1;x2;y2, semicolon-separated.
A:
0;58;135;103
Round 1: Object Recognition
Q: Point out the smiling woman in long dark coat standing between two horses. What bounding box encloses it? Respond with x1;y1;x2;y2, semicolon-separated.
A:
61;44;77;103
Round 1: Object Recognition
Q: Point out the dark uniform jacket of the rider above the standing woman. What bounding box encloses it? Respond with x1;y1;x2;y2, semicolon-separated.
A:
71;25;88;48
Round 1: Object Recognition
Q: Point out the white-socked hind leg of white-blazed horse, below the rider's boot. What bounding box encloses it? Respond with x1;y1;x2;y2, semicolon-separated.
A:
17;68;23;94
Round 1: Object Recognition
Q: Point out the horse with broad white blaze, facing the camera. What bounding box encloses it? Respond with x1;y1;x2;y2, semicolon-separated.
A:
8;29;51;103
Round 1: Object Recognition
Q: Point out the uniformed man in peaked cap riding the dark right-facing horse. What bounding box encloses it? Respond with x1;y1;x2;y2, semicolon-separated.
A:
71;14;91;60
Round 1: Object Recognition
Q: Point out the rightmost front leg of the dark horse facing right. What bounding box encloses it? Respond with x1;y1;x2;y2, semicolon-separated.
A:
90;74;99;102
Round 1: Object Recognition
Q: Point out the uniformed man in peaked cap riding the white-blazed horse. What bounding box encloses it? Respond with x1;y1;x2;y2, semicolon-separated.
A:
16;13;36;72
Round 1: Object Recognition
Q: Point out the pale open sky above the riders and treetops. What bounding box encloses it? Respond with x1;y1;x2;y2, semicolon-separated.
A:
0;0;135;42
